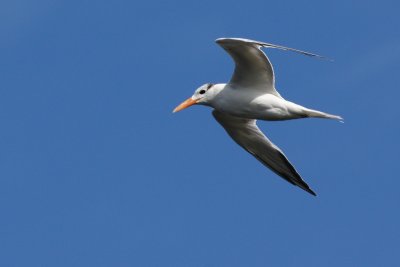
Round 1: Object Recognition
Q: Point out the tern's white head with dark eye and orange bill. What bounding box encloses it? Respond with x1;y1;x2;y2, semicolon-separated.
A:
173;83;222;113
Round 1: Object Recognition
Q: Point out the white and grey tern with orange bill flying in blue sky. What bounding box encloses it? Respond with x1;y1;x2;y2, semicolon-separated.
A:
173;38;342;196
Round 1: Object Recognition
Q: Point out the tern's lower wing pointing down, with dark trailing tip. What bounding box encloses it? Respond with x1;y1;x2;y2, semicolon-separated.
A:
213;110;316;196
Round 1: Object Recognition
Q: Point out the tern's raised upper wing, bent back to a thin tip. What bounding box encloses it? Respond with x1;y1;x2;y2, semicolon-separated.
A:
216;38;323;96
